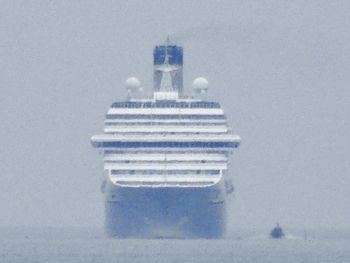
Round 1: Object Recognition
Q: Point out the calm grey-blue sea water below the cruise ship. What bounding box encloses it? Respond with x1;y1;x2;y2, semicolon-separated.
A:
0;228;350;263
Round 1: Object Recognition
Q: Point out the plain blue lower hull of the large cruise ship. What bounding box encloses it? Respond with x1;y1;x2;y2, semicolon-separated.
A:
105;184;226;238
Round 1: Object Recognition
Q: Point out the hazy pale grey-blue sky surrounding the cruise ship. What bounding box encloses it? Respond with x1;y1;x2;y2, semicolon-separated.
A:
0;0;350;227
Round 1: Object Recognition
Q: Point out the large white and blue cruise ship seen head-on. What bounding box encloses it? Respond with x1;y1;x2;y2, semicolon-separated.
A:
91;40;241;238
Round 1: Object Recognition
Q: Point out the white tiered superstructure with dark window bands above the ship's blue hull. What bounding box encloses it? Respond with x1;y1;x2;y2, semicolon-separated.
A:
92;99;240;187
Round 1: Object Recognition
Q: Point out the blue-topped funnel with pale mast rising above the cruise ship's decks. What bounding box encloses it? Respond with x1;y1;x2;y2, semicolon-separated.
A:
153;38;183;96
